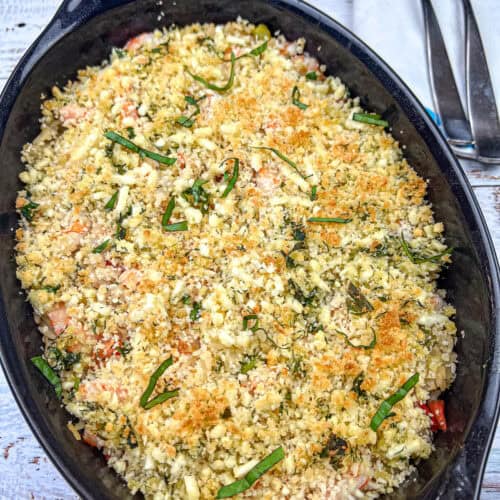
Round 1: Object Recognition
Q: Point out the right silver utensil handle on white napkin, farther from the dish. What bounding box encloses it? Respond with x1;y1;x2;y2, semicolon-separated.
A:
463;0;500;163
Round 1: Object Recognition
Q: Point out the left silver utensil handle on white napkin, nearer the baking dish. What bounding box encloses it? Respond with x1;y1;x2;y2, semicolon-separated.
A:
422;0;473;145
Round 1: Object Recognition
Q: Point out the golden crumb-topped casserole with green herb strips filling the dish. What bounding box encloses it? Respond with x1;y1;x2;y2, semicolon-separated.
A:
16;19;456;500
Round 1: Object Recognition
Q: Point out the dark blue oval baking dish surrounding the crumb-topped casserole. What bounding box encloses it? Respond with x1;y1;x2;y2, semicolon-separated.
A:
0;0;500;500
